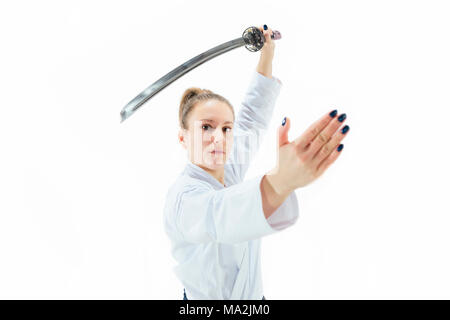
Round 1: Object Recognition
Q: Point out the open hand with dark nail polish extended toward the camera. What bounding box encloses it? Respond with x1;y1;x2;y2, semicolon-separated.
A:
266;113;348;195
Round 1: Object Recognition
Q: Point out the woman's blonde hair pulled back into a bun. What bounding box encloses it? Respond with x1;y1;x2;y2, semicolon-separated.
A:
178;87;234;129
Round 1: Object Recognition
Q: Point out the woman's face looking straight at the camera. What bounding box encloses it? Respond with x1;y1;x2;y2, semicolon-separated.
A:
179;100;234;170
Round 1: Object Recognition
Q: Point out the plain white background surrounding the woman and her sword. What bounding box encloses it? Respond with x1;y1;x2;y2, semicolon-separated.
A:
0;0;450;299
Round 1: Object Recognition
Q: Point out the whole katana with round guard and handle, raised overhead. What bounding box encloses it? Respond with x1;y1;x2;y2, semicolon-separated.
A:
120;27;281;122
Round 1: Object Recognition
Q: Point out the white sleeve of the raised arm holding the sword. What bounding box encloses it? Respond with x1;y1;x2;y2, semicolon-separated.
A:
229;71;282;181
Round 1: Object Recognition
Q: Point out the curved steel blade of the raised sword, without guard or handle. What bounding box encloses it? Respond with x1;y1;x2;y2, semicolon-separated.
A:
120;37;246;122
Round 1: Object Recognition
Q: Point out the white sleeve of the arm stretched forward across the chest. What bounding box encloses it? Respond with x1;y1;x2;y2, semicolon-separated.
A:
175;175;298;244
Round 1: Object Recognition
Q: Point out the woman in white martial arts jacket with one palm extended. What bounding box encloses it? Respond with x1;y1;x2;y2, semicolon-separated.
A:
164;25;348;300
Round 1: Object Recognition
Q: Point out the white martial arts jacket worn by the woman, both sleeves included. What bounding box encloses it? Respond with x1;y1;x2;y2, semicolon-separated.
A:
164;71;299;300
